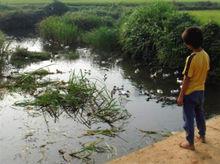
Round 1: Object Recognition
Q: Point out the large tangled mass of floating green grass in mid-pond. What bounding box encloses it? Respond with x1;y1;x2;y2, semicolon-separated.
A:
12;70;130;127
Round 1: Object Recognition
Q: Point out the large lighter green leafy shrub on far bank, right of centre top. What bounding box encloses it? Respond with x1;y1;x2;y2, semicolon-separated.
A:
119;3;173;57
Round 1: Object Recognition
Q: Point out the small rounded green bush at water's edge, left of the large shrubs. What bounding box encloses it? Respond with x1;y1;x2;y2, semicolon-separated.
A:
84;27;118;51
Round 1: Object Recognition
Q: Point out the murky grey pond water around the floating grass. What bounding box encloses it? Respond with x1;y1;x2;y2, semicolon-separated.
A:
0;38;220;164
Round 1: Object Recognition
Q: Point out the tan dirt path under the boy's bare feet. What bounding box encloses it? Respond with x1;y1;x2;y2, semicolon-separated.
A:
109;116;220;164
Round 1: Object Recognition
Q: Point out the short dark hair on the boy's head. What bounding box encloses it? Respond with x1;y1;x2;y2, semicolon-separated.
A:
182;27;203;48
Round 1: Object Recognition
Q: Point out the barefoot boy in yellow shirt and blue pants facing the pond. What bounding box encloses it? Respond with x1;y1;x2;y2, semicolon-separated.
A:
177;27;209;150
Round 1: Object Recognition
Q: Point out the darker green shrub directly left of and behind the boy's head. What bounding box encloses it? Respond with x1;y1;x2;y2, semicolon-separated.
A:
156;12;196;68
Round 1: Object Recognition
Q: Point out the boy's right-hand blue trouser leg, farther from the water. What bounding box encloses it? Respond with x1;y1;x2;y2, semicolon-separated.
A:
195;92;206;142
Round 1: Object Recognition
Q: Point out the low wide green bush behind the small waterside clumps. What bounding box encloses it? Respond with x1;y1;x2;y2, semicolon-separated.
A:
65;12;113;31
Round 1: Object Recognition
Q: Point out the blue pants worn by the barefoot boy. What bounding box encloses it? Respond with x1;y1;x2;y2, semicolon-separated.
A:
183;91;206;144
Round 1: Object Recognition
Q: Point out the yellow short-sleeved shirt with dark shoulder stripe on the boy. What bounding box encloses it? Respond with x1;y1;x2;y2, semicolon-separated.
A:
183;50;209;95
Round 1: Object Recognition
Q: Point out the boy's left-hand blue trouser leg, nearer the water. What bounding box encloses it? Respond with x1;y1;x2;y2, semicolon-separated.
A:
183;95;195;145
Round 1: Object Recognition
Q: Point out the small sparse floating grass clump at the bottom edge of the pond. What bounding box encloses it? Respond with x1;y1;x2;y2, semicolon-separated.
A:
59;139;115;162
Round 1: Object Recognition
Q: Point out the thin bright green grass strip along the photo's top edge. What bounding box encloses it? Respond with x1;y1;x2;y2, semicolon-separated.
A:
0;0;219;4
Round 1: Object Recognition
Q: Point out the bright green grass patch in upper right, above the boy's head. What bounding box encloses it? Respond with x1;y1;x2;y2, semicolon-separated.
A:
188;10;220;24
